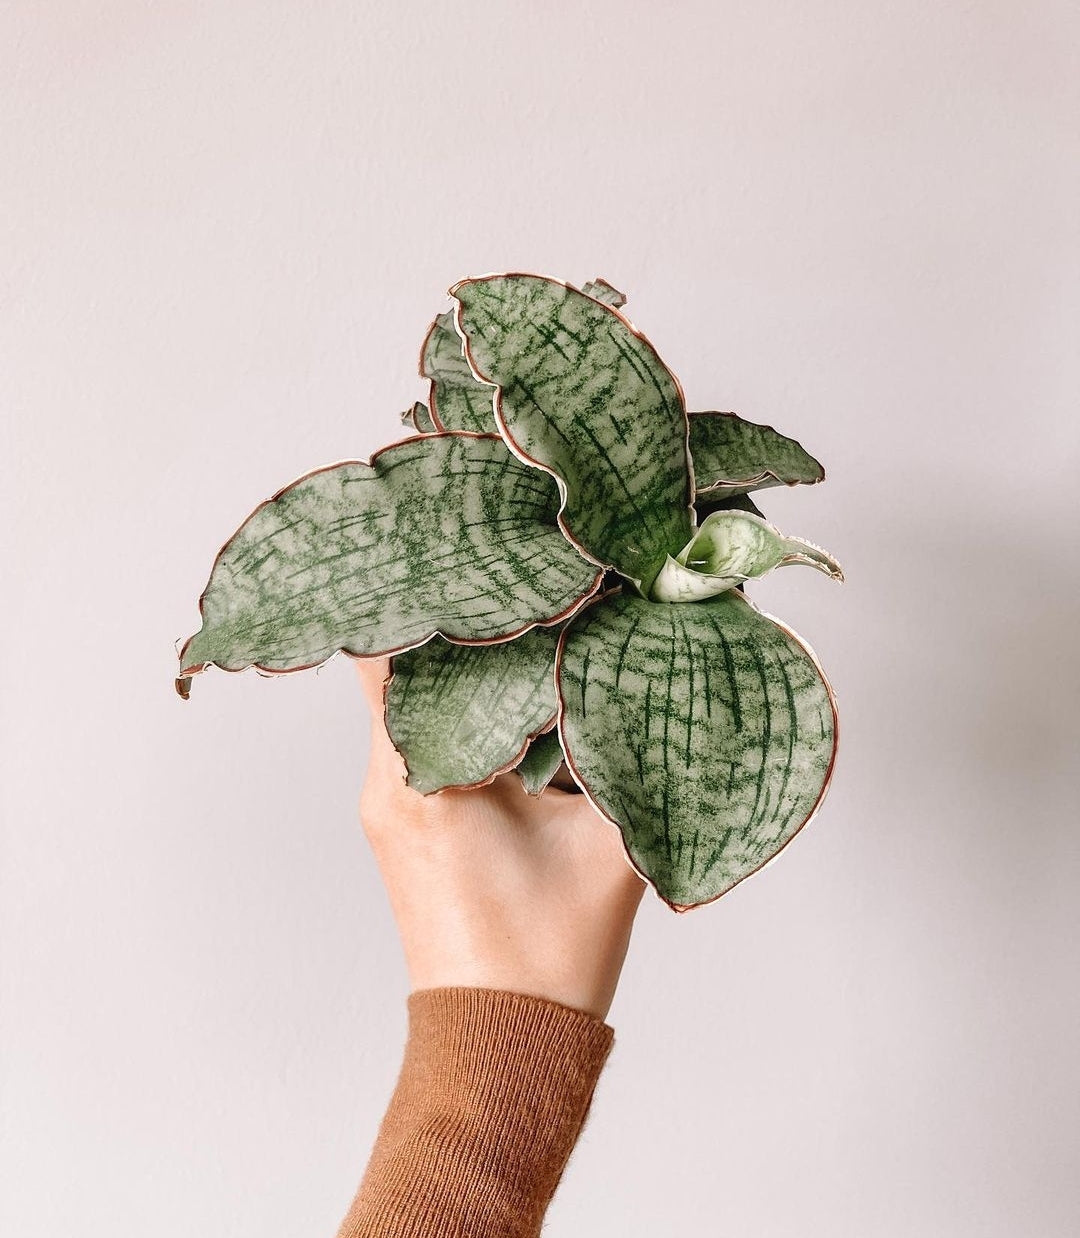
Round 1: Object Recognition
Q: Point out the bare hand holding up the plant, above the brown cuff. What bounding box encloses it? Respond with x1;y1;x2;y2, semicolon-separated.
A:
357;659;645;1019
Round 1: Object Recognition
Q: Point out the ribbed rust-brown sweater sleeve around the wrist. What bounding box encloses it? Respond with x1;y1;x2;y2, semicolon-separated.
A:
338;988;613;1238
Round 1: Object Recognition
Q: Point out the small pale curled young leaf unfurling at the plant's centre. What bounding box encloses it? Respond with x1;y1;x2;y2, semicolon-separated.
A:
651;510;843;602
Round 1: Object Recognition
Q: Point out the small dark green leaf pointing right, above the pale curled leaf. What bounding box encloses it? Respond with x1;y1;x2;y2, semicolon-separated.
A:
690;412;825;499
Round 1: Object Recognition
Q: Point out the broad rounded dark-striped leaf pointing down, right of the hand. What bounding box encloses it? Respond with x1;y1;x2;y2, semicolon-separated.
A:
559;592;836;909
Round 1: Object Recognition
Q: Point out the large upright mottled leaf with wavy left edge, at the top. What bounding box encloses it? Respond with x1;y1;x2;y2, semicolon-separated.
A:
451;275;691;592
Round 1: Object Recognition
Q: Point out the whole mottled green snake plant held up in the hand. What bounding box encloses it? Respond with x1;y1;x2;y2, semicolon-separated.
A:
177;275;842;911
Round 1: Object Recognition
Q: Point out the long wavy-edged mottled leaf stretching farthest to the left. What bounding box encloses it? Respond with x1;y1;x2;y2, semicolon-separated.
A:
181;435;598;688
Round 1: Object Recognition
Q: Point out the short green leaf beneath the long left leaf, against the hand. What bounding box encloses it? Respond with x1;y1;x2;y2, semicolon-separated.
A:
386;628;559;795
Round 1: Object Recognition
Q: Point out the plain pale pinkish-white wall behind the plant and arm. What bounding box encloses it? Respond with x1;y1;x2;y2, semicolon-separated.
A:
0;0;1080;1238
